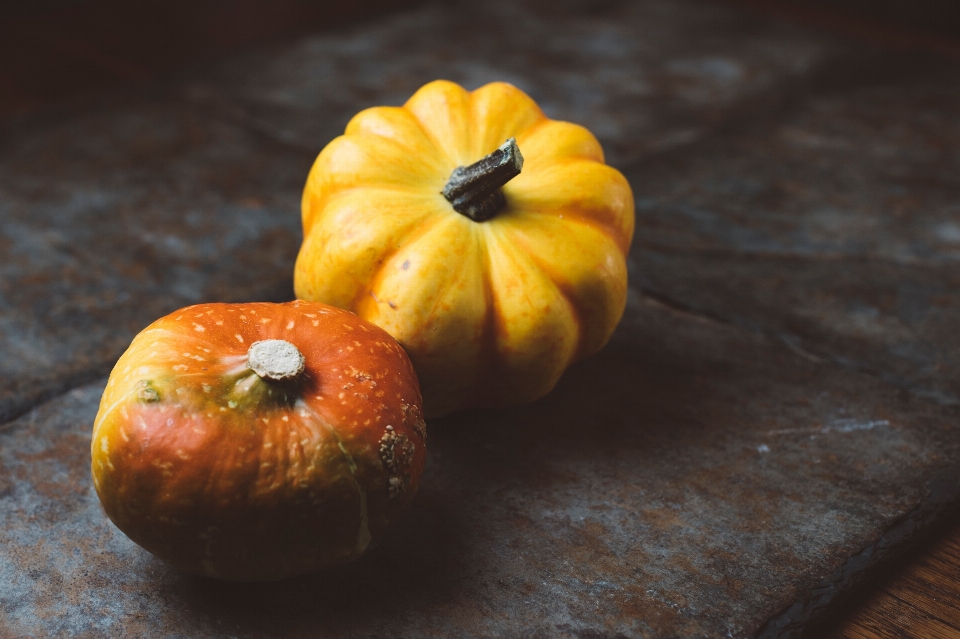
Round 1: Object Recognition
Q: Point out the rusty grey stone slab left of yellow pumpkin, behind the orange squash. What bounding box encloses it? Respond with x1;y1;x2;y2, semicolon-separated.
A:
0;91;311;422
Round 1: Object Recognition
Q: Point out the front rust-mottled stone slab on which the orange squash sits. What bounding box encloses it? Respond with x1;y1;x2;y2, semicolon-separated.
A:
0;298;960;637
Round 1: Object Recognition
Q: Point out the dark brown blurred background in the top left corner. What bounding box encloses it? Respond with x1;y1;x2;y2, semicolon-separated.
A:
0;0;416;116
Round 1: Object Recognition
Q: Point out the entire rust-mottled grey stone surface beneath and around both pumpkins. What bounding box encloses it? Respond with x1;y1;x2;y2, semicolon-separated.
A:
0;0;960;637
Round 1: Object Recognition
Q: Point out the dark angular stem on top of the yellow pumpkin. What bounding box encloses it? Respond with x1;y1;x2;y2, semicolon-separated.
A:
441;138;523;222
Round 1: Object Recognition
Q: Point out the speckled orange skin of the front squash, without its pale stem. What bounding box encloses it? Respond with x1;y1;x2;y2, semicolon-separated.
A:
91;301;426;581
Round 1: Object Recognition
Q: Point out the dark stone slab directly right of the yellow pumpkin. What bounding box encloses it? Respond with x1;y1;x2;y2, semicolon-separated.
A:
627;52;960;405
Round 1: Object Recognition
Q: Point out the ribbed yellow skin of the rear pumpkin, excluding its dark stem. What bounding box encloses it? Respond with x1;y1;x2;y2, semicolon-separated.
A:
294;81;634;417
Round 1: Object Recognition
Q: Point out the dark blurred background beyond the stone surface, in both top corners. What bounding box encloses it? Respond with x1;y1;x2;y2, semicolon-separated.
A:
0;0;960;116
